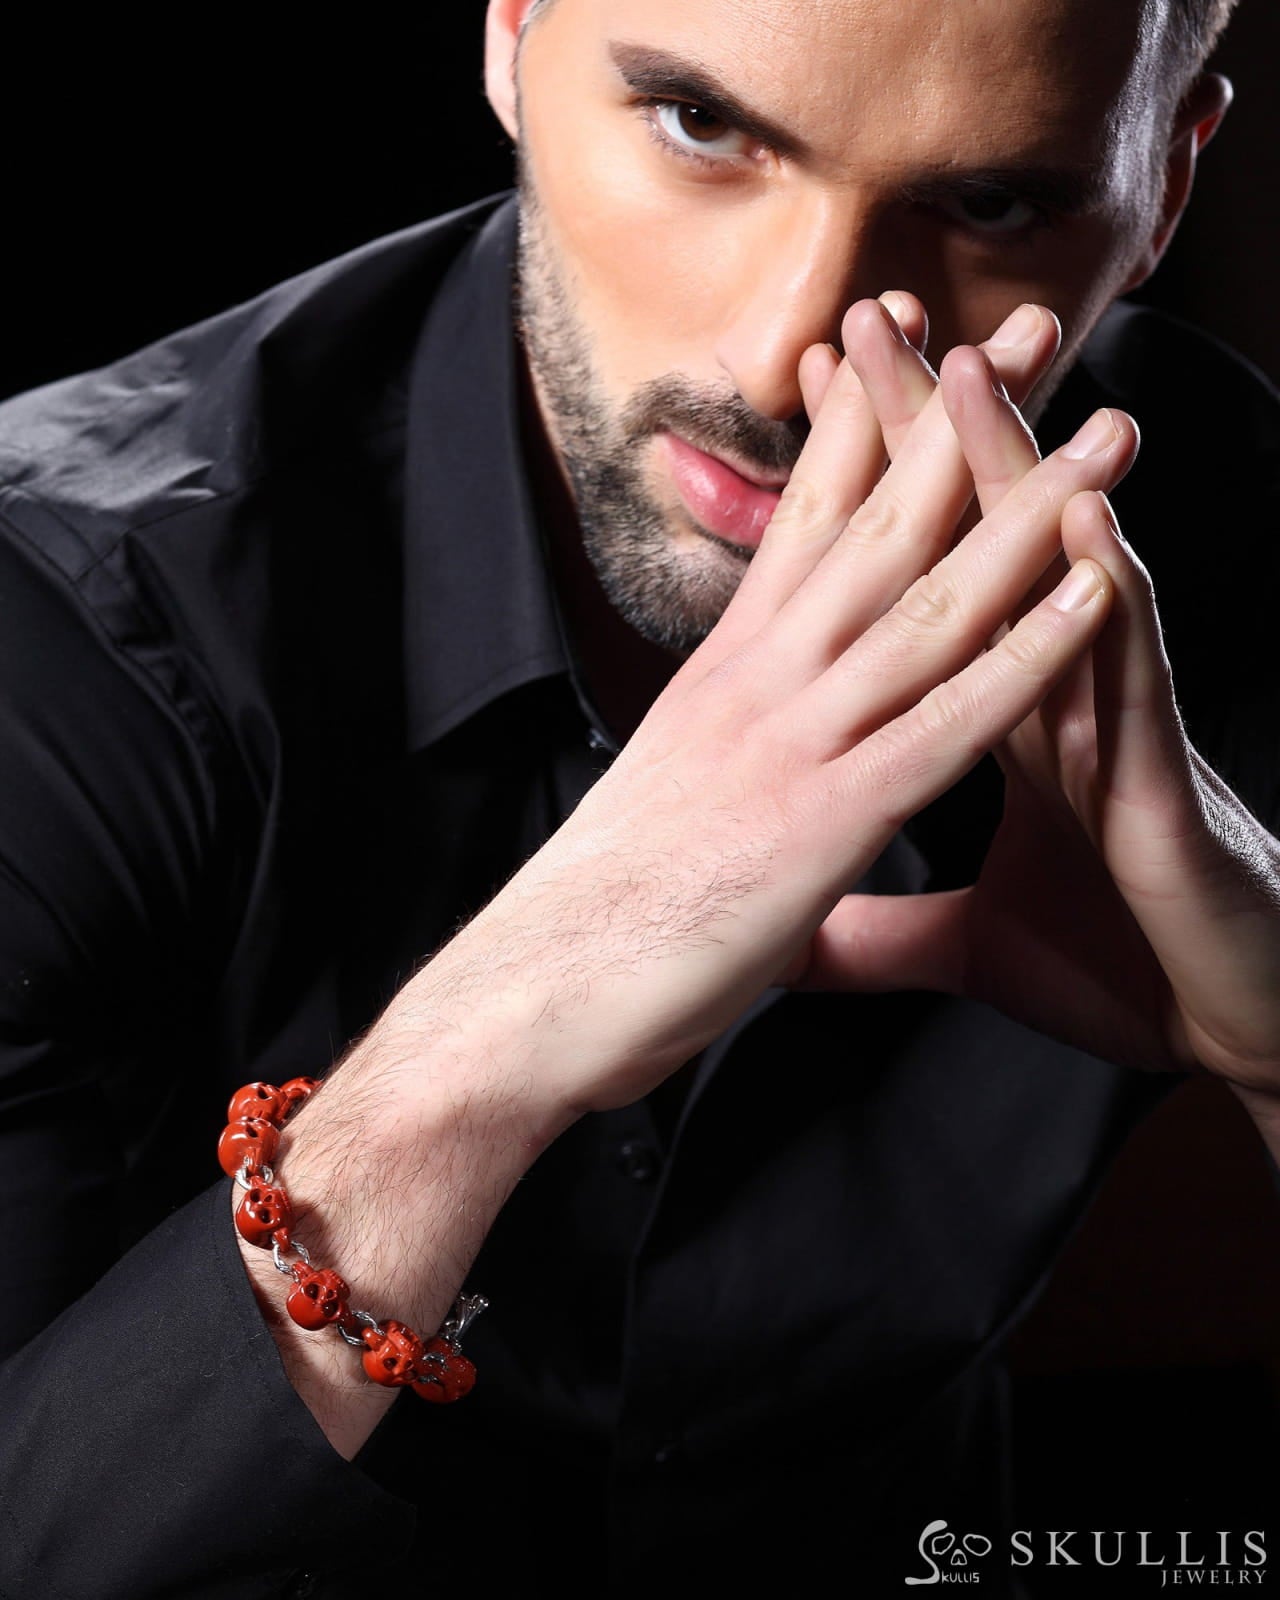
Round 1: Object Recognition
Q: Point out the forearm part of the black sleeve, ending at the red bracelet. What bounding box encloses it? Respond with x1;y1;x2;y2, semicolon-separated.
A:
0;1181;416;1600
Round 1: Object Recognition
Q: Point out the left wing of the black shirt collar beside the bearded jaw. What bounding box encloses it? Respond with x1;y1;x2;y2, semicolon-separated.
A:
403;198;568;749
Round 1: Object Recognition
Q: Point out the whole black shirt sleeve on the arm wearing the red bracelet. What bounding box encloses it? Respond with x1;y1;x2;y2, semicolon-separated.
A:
0;518;413;1600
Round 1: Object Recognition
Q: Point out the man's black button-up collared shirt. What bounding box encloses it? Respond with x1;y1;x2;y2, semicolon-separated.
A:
0;200;1280;1600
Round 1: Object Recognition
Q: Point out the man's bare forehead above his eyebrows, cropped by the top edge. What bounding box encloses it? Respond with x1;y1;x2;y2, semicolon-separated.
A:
560;0;1166;165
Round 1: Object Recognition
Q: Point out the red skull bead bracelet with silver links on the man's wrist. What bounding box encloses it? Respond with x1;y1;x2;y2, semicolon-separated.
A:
218;1078;488;1405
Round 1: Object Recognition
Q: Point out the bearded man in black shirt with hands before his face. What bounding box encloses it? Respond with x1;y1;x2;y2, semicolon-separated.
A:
0;0;1280;1595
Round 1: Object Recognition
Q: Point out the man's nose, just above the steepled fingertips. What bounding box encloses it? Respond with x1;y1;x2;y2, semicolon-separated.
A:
715;195;893;421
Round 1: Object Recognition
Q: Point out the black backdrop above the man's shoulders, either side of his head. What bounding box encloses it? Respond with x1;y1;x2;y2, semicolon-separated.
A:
0;0;1280;394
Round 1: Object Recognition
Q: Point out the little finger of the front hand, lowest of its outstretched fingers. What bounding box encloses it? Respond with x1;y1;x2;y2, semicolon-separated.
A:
819;560;1112;851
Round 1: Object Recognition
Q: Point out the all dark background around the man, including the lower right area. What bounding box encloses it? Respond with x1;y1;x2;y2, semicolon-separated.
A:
0;0;1280;1594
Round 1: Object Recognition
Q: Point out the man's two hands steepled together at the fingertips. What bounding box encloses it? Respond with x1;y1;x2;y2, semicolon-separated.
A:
441;296;1280;1117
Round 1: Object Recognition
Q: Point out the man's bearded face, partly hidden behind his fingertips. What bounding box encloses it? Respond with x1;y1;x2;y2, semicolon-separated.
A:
505;0;1162;654
